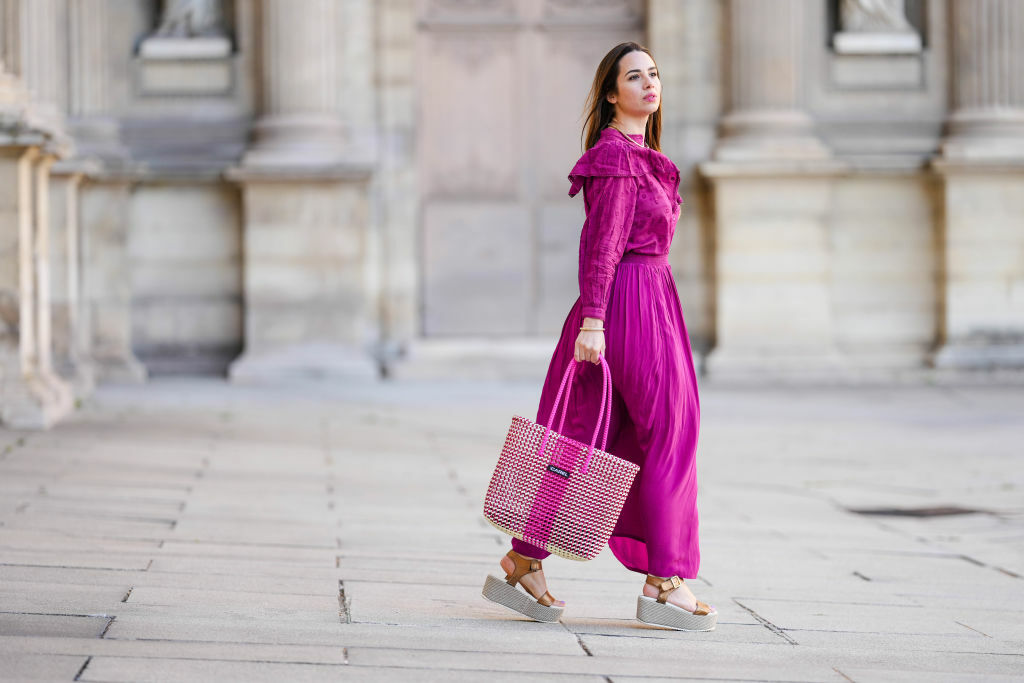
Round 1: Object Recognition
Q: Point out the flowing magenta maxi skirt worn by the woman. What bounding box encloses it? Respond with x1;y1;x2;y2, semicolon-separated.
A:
512;252;700;579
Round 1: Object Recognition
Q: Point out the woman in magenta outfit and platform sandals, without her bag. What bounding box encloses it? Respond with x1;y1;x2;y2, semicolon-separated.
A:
485;43;718;631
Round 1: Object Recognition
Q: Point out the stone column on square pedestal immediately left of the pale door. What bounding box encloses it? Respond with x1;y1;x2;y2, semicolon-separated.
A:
229;0;378;381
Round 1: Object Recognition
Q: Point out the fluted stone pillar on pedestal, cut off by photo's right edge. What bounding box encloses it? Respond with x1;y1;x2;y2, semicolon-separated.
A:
933;0;1024;369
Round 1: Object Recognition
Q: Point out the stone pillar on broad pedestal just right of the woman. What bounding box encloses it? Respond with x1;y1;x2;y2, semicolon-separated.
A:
700;0;844;377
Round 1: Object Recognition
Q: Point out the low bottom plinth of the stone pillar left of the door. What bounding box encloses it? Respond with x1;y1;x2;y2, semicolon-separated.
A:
227;343;380;384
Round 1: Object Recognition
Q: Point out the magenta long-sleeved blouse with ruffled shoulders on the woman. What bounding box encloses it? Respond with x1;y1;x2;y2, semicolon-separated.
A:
568;128;683;321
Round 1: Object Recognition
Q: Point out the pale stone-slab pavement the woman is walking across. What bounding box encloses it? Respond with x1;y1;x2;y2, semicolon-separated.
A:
0;380;1024;683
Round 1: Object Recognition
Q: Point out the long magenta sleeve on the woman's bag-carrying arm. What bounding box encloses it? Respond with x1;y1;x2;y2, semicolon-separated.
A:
580;175;638;321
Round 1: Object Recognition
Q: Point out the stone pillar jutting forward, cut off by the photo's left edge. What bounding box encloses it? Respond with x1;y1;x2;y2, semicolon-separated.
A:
0;0;73;429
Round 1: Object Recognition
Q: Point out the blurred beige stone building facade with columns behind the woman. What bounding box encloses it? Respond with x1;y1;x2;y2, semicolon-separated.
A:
0;0;1024;426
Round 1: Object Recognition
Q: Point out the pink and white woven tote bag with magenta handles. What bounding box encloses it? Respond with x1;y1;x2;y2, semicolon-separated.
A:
483;355;640;560
